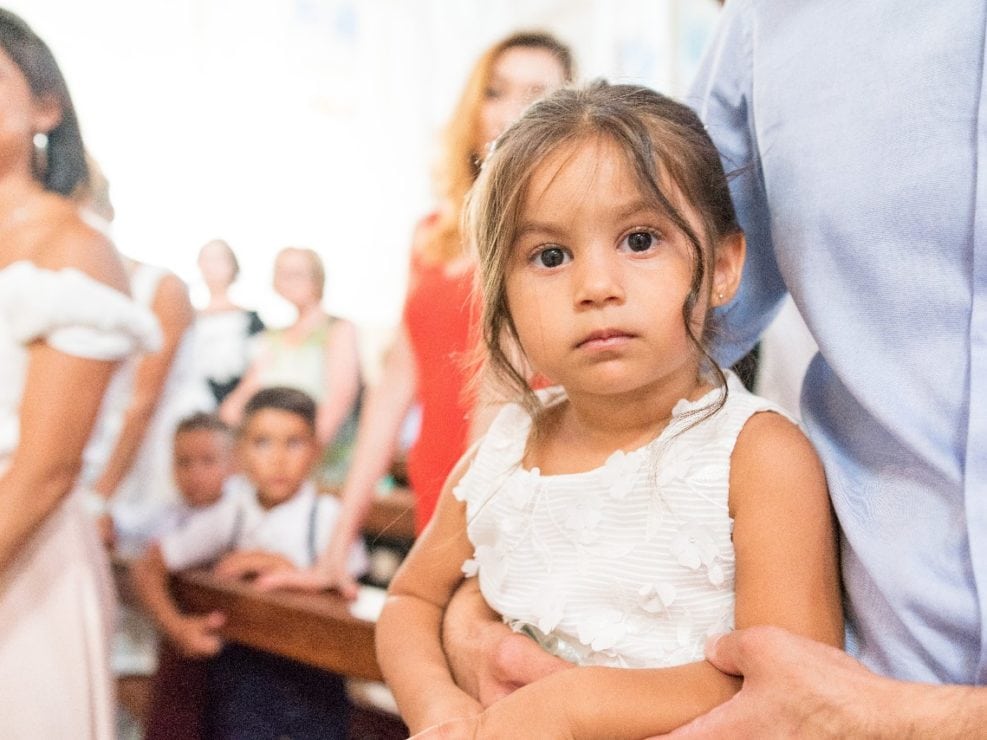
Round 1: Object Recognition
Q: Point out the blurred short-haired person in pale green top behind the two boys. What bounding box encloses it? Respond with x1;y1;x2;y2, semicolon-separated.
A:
219;247;360;480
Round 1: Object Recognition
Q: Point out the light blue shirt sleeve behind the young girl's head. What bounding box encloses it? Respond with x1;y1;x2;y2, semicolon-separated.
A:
686;0;786;366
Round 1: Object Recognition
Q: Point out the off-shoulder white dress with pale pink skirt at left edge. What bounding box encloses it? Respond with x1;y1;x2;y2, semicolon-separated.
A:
0;261;160;740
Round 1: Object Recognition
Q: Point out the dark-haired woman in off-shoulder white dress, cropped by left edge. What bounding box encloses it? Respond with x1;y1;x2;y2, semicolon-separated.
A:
0;10;159;738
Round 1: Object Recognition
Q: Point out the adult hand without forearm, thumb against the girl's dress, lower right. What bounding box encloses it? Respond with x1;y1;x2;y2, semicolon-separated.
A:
665;627;902;740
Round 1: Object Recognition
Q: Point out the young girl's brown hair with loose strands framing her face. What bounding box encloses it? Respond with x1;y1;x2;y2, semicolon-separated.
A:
465;81;740;416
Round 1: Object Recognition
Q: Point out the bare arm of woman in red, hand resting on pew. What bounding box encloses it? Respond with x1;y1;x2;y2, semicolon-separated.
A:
257;324;418;598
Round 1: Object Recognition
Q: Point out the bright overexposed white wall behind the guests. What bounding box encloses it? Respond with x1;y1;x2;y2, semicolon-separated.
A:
5;0;718;370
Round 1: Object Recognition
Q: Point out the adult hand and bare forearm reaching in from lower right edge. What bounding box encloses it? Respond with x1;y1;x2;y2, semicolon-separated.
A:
669;627;987;740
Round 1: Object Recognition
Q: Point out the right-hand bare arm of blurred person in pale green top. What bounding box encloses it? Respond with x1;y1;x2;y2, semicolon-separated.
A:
315;319;360;446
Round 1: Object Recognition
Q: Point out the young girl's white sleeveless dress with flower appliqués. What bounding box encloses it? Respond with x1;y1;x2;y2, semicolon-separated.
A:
455;373;790;668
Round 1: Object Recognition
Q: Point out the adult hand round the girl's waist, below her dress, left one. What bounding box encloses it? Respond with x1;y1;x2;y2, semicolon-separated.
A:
442;578;573;707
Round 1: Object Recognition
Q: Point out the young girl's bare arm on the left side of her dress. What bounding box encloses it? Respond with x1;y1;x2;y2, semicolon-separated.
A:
376;453;484;737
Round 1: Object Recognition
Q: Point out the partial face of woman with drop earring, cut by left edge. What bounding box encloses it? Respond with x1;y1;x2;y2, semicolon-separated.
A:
0;47;61;178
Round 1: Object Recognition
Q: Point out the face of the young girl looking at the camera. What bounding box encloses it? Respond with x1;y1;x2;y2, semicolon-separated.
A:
505;138;743;396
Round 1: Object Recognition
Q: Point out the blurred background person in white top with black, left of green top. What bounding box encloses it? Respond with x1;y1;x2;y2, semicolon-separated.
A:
195;239;264;404
